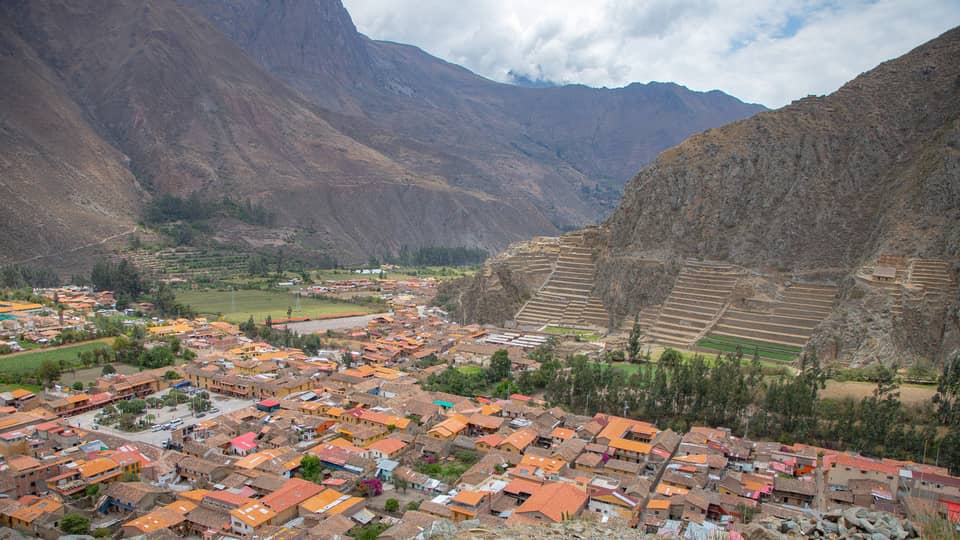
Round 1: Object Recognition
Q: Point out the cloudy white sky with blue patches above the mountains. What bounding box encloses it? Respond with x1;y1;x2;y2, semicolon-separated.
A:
344;0;960;107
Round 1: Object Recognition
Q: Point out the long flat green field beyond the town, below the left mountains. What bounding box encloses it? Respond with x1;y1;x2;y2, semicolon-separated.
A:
177;290;383;323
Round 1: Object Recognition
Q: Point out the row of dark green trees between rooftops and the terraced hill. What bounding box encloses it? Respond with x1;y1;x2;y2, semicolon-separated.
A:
426;340;960;472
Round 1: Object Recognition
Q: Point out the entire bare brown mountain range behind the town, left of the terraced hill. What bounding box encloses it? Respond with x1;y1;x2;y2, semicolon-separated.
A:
0;0;762;263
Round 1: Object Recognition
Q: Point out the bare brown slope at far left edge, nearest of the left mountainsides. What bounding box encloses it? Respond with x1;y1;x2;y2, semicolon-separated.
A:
0;17;140;262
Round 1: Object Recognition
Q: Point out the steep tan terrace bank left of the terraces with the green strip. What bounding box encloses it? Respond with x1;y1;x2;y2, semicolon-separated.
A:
641;259;741;348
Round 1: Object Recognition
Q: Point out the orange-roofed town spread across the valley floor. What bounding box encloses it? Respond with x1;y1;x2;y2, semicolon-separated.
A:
0;266;960;539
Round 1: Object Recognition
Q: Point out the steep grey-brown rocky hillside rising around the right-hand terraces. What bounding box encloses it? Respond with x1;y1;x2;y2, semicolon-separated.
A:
462;29;960;362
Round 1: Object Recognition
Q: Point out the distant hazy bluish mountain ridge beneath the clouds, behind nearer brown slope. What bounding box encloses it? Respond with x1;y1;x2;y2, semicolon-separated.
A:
180;0;763;228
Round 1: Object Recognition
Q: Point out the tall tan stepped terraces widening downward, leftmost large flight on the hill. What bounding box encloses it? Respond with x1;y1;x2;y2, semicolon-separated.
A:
515;233;609;328
